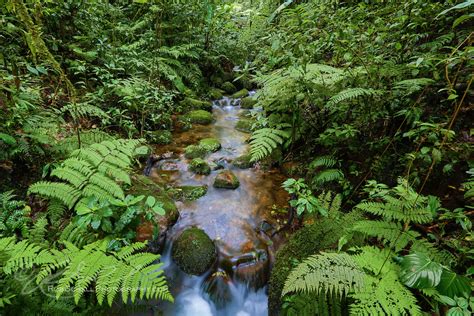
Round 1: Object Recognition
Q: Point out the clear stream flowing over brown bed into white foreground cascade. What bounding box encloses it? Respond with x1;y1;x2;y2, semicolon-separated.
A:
151;97;287;316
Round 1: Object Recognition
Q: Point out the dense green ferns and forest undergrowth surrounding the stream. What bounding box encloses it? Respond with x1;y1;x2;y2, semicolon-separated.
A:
0;0;474;315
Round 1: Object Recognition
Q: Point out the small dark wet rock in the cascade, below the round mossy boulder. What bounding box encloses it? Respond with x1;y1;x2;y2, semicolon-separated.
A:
203;269;232;309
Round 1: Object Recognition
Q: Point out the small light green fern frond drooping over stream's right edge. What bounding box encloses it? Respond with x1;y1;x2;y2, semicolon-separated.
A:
250;128;289;161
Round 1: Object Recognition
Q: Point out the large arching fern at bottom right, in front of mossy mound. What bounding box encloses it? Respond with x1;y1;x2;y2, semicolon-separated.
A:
283;247;421;315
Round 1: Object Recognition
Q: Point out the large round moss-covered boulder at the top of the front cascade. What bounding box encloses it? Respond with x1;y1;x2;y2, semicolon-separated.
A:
171;227;217;275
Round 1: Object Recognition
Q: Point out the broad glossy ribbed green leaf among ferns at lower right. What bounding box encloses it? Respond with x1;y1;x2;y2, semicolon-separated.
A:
400;253;443;289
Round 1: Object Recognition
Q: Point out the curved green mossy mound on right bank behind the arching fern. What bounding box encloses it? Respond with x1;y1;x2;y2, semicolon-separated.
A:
268;212;362;315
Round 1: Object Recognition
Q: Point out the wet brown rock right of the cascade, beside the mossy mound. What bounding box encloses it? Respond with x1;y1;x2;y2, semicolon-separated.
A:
232;249;270;290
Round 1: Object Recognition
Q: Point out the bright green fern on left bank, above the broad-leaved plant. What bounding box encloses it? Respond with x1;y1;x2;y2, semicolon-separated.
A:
28;140;140;209
